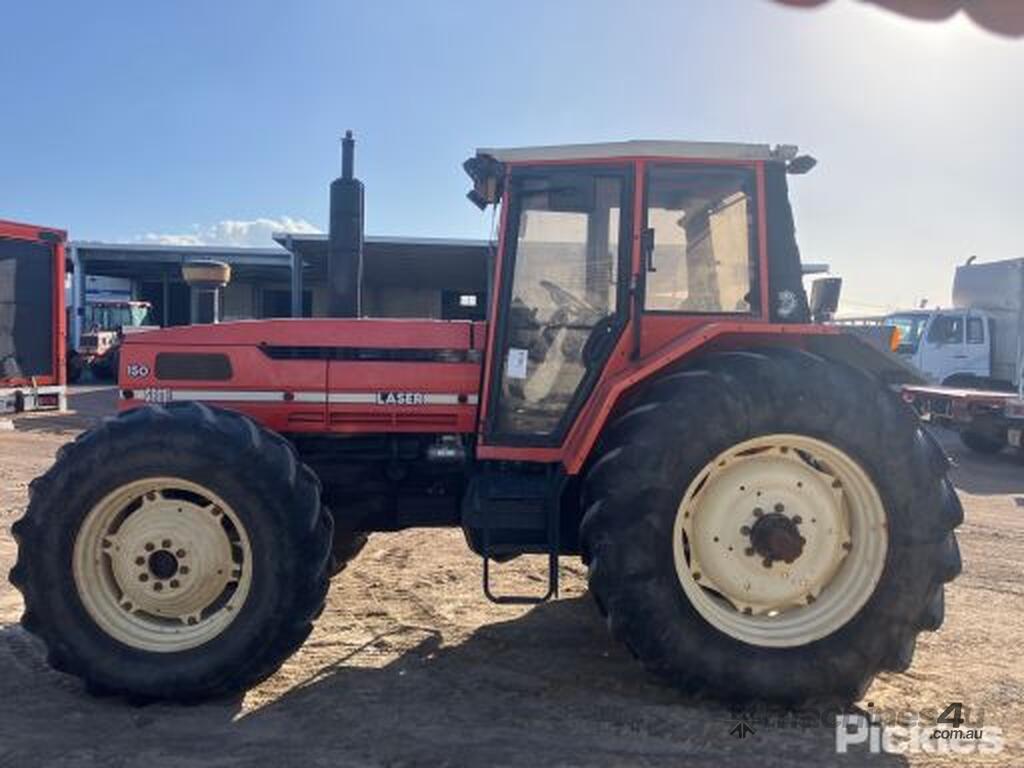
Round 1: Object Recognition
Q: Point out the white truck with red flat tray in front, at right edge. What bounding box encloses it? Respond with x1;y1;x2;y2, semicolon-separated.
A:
905;259;1024;454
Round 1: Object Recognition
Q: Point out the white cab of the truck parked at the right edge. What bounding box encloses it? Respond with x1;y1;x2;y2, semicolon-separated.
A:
885;309;992;384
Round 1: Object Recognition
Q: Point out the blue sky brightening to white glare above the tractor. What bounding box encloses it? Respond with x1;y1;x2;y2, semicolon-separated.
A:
0;0;1024;311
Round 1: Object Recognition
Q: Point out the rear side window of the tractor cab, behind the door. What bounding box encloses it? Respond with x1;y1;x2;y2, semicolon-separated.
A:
644;165;757;313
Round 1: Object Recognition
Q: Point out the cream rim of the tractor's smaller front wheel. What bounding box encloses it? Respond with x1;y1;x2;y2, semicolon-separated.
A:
72;477;252;652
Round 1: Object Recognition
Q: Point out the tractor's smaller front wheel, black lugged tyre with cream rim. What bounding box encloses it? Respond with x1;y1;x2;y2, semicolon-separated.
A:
10;403;333;700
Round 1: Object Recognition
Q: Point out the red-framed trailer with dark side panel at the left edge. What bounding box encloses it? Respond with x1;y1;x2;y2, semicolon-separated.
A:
0;219;67;414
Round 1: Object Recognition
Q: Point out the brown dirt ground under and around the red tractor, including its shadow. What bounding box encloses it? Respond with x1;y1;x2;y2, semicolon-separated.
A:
0;387;1024;768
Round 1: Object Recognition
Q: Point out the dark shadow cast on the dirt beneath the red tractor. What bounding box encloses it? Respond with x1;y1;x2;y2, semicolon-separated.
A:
0;597;905;768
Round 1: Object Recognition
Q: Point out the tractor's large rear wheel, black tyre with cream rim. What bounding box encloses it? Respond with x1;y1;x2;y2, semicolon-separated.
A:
581;350;963;705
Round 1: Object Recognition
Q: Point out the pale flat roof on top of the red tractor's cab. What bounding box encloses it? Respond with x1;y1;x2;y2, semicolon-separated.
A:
476;140;797;163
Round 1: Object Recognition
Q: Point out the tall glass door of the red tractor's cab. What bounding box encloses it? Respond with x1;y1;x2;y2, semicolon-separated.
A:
484;163;633;446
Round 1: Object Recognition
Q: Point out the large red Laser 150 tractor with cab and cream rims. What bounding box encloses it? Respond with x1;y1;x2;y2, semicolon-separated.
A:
11;141;963;703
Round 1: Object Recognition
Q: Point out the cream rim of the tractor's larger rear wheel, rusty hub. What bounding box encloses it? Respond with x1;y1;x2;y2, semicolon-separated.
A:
673;434;889;647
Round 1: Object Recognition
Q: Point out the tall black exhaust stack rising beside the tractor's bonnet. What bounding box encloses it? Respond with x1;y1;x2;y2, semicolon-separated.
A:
327;131;362;317
